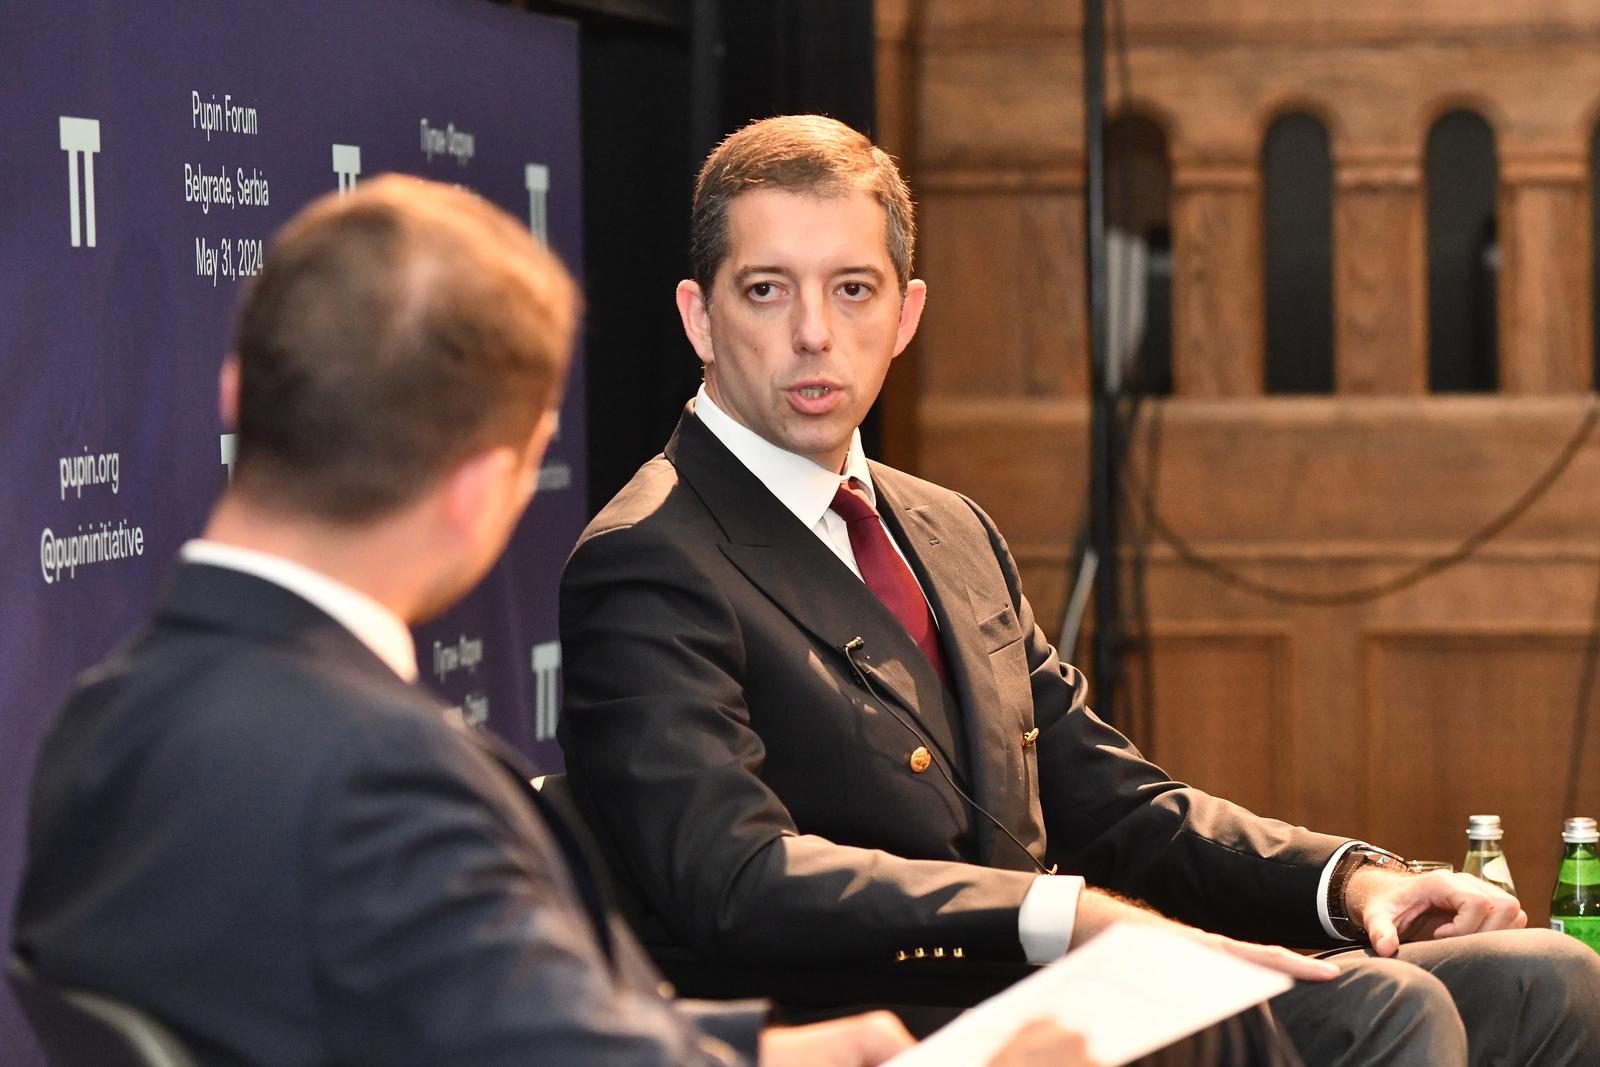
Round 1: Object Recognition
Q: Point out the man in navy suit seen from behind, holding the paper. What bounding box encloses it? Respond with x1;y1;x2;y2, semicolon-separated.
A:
14;178;972;1067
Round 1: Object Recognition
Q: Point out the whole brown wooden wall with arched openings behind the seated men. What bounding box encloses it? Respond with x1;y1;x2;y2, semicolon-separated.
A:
880;0;1600;918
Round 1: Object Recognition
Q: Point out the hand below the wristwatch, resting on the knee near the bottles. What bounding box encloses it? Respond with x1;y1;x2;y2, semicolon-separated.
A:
1344;867;1528;957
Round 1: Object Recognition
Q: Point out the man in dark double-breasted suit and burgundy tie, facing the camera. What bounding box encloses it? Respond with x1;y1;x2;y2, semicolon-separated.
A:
560;117;1600;1064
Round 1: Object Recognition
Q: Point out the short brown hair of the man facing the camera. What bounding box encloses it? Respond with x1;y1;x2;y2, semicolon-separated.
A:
690;115;917;295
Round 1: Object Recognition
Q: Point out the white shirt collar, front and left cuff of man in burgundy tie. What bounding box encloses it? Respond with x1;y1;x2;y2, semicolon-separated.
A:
694;386;1083;963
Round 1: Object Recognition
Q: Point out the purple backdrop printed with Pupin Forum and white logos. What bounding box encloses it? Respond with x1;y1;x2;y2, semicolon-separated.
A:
0;0;586;1065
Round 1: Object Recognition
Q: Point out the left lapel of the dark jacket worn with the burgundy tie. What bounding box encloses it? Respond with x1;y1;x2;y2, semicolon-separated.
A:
666;410;957;766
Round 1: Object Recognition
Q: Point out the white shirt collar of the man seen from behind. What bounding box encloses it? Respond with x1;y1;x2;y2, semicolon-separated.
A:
178;539;418;681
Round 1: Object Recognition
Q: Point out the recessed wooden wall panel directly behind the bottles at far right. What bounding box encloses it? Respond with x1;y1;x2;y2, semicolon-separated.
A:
1366;627;1600;925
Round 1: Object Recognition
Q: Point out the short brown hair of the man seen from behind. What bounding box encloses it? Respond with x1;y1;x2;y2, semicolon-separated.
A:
234;176;578;523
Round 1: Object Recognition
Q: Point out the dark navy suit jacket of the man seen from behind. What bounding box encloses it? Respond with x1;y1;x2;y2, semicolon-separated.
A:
16;565;762;1064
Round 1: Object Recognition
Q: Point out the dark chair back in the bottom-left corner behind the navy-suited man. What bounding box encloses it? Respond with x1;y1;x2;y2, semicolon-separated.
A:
5;955;195;1067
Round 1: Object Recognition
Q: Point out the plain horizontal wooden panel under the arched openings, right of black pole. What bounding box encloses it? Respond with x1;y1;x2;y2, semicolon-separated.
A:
1133;397;1600;553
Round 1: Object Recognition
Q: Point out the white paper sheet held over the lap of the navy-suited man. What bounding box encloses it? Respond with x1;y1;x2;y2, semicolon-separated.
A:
890;923;1294;1067
